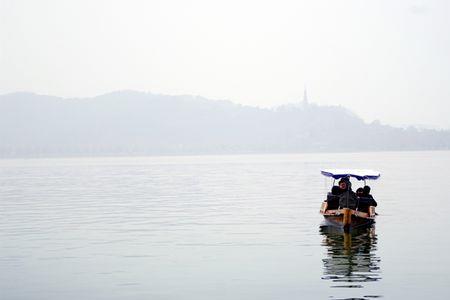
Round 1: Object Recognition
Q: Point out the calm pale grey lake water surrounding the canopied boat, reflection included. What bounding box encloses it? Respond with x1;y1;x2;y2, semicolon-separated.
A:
0;152;450;300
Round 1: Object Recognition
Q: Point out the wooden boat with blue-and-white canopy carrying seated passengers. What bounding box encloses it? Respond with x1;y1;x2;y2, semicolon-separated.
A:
320;169;381;231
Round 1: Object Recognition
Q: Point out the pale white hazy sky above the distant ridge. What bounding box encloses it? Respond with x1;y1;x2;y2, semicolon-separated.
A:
0;0;450;128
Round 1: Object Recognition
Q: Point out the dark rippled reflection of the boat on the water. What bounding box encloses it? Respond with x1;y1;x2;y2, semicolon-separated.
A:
320;226;381;299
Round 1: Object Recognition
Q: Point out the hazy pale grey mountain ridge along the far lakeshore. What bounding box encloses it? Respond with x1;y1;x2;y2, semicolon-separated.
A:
0;91;450;157
